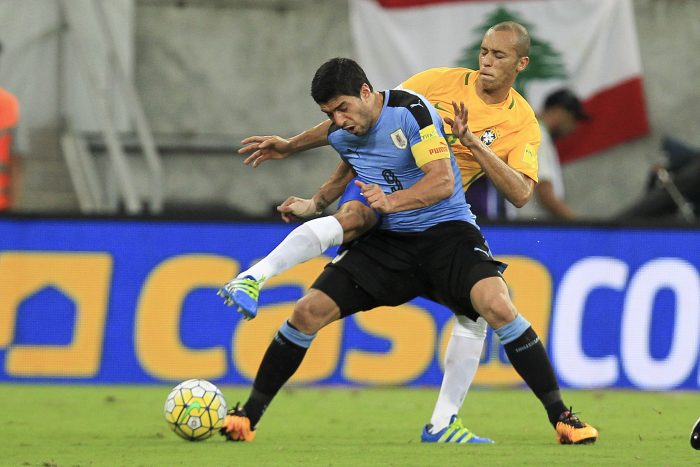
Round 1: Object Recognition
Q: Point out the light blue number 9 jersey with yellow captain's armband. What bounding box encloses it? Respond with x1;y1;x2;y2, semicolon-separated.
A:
328;90;476;232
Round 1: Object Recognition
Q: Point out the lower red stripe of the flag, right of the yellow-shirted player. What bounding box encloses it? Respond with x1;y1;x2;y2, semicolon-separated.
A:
557;78;649;162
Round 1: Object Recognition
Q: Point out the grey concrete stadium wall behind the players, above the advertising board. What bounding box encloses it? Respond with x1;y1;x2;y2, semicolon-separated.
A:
0;0;700;219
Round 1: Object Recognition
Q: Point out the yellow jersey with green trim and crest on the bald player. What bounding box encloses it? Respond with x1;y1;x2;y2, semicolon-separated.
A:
399;68;540;190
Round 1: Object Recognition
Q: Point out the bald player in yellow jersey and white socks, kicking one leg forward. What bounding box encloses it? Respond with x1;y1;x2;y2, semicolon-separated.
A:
219;21;598;444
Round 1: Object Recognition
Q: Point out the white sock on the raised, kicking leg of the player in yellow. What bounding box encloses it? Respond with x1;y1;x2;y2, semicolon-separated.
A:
238;216;343;285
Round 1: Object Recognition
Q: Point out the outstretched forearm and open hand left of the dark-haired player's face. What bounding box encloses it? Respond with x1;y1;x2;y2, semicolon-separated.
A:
238;120;331;167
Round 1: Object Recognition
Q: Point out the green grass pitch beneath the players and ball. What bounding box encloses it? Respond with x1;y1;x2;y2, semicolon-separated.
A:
0;384;700;467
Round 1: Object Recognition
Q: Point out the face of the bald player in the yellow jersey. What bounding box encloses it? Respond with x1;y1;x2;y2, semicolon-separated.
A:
479;30;529;91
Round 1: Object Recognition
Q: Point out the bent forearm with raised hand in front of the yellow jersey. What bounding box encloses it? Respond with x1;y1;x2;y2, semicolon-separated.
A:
444;101;535;208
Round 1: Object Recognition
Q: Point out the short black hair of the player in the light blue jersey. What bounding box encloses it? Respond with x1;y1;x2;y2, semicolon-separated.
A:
311;57;373;104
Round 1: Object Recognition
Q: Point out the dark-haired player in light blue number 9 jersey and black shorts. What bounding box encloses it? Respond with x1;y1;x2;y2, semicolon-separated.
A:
222;58;597;443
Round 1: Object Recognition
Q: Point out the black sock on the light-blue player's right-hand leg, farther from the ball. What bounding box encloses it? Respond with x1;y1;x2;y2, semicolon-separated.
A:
503;327;566;426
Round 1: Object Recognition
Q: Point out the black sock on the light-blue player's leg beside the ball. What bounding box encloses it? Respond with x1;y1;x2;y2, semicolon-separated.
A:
243;332;308;428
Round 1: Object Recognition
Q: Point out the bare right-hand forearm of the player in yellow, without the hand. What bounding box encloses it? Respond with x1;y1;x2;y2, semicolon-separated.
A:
465;139;535;208
